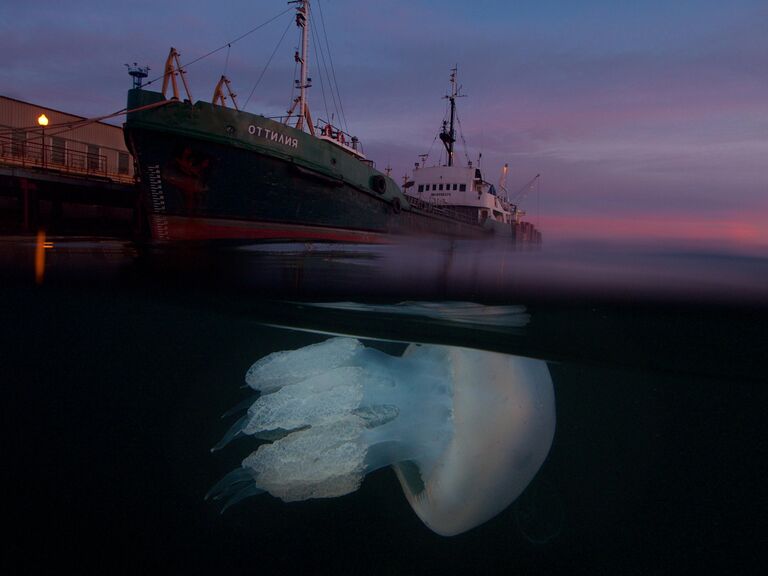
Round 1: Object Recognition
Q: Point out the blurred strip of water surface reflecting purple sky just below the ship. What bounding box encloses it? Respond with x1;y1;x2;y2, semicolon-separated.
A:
0;237;768;302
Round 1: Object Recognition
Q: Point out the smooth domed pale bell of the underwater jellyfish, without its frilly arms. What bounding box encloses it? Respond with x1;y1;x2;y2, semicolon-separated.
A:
394;348;555;536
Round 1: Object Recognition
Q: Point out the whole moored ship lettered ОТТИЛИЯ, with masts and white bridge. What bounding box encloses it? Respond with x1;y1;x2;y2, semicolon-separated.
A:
124;0;540;244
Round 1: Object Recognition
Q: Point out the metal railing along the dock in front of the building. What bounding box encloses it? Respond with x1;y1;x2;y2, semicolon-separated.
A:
0;134;135;184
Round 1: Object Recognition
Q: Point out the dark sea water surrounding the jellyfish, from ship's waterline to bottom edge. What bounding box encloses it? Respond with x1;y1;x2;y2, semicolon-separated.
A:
0;236;768;574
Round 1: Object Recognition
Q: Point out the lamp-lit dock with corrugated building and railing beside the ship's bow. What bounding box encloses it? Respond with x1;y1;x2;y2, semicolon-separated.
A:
0;96;139;233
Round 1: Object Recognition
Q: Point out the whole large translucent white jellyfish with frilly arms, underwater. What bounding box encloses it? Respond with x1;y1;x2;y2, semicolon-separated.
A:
209;337;555;536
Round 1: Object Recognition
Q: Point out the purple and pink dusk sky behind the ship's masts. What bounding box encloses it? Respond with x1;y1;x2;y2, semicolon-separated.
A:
0;0;768;247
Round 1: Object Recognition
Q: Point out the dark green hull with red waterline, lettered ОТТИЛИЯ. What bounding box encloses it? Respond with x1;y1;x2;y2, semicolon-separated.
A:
124;89;540;243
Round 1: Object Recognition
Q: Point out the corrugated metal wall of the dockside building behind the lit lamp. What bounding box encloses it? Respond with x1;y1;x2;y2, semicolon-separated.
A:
0;96;133;175
